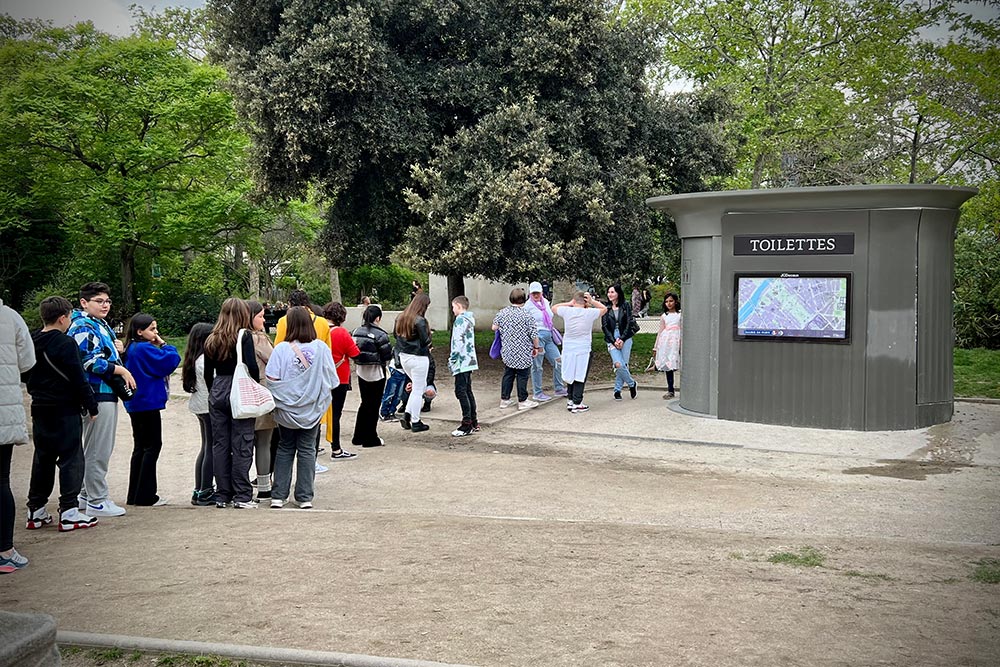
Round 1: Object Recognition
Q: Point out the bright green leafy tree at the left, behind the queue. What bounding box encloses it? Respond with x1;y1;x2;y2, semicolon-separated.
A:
0;24;260;314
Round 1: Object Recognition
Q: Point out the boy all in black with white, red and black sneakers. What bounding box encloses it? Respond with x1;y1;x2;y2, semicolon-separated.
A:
25;296;98;532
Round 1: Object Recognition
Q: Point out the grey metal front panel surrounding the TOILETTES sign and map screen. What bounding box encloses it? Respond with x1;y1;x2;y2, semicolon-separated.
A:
720;211;868;429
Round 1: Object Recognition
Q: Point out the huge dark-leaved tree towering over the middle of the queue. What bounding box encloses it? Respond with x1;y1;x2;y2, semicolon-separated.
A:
209;0;725;278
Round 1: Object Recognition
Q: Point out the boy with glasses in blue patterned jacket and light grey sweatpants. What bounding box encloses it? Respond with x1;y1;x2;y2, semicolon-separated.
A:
67;282;135;516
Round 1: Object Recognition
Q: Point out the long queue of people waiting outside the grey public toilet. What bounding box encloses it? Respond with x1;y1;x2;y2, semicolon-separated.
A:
0;282;681;573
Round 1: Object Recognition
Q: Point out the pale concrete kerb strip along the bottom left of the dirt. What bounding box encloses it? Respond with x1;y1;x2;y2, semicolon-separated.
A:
56;630;480;667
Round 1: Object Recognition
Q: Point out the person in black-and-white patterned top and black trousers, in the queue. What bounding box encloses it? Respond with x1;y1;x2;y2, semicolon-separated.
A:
493;287;542;410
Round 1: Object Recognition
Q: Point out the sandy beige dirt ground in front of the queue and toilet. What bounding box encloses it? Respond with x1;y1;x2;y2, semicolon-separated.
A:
0;374;1000;666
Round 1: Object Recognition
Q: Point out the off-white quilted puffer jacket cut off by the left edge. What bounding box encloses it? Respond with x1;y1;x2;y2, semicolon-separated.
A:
0;300;35;446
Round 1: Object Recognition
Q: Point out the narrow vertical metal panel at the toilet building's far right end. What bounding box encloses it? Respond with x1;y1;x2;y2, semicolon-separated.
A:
917;209;958;404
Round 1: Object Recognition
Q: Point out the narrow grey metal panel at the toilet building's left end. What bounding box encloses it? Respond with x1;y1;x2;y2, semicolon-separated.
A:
680;237;719;415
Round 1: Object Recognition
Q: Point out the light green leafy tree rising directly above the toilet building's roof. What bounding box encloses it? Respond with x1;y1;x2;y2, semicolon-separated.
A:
637;0;946;188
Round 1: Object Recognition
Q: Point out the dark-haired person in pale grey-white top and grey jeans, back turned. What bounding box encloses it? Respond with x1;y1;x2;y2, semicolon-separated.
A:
265;306;339;509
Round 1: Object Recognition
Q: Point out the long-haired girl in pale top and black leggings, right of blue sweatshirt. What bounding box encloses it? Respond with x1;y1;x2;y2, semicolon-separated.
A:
181;322;215;507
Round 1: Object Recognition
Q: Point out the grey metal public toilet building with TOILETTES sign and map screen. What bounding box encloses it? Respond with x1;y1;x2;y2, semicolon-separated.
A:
647;185;976;430
